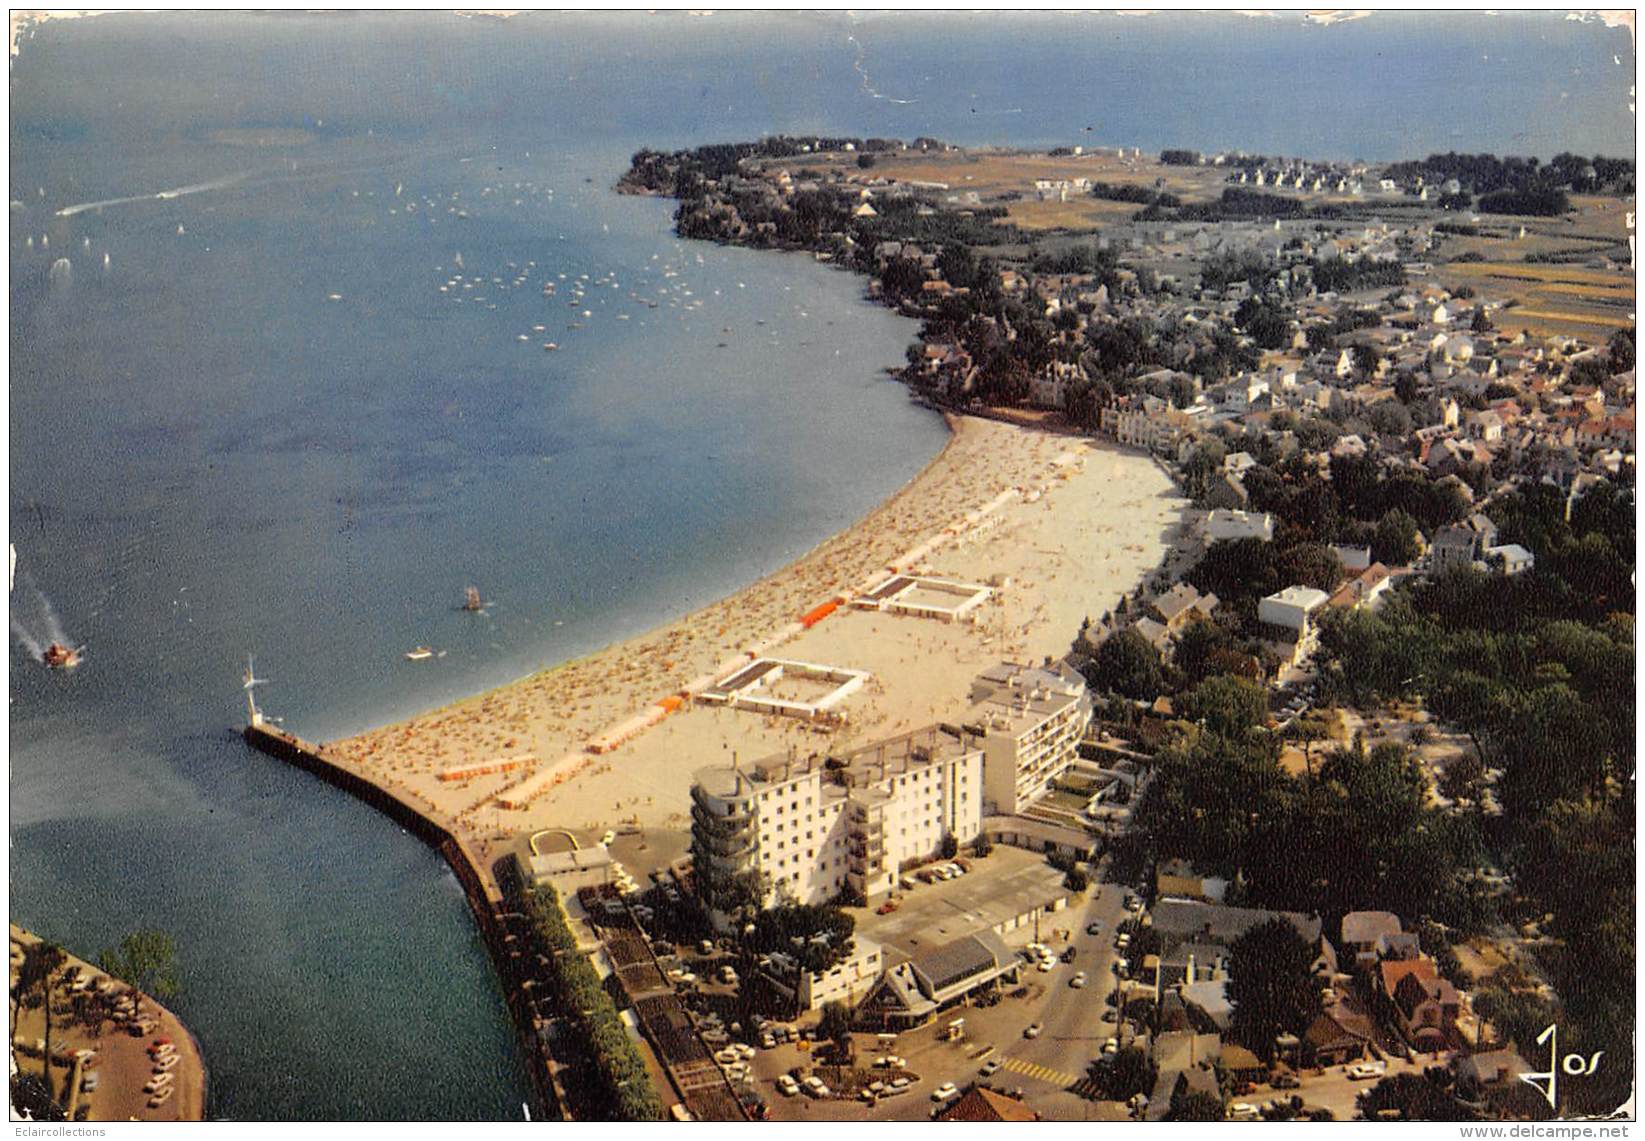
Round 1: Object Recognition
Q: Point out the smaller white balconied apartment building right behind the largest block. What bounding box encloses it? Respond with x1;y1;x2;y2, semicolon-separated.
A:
966;663;1091;815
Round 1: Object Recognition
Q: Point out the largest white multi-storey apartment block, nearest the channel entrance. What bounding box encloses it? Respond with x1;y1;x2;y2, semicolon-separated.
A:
691;727;984;904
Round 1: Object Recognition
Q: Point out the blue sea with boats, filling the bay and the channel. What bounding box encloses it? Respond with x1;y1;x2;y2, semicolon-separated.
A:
8;13;1633;1120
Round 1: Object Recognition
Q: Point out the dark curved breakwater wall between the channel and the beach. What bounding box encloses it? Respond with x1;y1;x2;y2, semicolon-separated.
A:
243;722;571;1121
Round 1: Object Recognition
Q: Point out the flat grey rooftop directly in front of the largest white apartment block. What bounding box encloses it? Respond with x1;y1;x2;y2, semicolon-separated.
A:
852;843;1068;962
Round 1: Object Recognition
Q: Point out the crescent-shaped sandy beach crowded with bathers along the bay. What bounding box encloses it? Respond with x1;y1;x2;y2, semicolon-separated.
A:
326;418;1186;858
